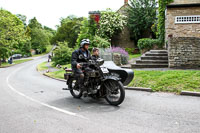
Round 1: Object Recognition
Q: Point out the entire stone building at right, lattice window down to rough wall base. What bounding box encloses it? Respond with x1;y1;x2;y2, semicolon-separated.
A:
165;0;200;68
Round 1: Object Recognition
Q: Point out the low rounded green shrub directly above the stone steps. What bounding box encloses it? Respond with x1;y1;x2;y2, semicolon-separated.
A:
137;38;160;50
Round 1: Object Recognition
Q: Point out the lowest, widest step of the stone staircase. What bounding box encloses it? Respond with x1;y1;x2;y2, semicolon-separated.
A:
131;63;168;68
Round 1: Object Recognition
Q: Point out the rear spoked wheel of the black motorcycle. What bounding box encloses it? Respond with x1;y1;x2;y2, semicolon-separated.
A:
68;79;82;98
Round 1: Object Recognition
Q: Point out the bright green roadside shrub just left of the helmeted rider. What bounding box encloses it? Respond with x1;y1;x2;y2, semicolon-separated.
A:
52;42;73;66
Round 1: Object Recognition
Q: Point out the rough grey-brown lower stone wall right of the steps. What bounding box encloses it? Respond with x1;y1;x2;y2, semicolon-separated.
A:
168;37;200;68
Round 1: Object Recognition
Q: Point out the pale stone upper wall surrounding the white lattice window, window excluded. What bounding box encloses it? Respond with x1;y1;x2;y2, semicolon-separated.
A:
165;7;200;40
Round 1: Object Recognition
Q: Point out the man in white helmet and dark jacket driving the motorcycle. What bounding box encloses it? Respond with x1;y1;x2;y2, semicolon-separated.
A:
71;39;91;96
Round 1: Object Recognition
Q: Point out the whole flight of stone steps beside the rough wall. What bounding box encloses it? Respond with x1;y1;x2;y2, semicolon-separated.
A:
131;50;168;68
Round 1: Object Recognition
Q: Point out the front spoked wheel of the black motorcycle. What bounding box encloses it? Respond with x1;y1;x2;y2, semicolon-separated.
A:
104;80;125;106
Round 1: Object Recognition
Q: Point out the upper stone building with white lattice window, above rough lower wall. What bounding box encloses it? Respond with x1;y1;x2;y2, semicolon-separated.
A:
166;0;200;37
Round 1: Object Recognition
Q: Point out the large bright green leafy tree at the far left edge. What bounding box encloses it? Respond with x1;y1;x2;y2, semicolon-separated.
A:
0;9;30;64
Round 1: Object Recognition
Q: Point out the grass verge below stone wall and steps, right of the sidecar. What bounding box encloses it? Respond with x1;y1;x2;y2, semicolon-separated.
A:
128;70;200;93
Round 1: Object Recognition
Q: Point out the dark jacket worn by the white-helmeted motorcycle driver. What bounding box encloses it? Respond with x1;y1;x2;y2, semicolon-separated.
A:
71;49;91;71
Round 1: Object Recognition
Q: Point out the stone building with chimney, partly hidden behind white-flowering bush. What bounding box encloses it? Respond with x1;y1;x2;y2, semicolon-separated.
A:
111;0;135;48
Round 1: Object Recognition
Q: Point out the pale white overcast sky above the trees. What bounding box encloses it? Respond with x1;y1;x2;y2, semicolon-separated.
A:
0;0;124;29
